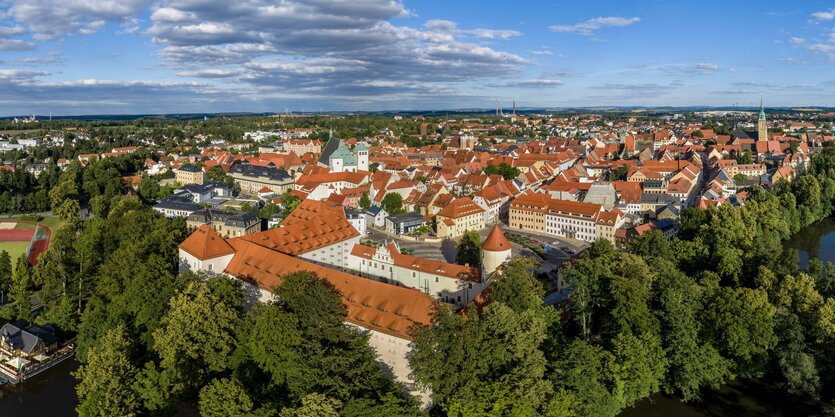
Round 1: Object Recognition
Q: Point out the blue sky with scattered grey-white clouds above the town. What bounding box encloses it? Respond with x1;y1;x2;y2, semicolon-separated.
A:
0;0;835;116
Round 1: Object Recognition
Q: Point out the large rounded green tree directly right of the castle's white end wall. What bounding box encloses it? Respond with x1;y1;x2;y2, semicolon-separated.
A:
410;302;552;416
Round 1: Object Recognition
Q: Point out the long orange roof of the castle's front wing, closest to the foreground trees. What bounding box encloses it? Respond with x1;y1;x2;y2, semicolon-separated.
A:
226;239;436;340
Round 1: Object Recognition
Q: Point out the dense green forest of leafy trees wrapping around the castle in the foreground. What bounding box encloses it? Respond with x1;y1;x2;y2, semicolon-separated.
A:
0;122;835;417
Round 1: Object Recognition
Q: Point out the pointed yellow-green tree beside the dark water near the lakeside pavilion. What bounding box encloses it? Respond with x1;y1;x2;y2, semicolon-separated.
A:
75;327;141;417
